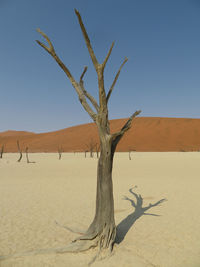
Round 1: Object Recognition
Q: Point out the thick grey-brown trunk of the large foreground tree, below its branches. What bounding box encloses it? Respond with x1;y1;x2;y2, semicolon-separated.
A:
80;140;116;250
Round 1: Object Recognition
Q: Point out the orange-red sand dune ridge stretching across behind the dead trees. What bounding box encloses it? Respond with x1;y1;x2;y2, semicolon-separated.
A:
0;117;200;152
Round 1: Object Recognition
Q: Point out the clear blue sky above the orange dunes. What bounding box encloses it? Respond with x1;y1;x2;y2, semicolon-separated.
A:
0;0;200;132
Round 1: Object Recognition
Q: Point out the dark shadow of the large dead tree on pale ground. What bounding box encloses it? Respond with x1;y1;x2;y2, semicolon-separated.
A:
115;188;167;244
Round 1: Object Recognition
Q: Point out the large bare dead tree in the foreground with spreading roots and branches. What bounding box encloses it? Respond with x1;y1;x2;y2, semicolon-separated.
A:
0;10;141;259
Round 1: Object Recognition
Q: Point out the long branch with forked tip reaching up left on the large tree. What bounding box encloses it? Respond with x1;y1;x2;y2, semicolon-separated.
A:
36;29;97;122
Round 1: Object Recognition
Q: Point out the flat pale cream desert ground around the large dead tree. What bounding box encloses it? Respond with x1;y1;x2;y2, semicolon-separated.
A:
0;152;200;267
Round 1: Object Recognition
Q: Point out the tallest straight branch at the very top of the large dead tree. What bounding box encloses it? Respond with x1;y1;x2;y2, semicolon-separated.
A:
75;9;99;71
